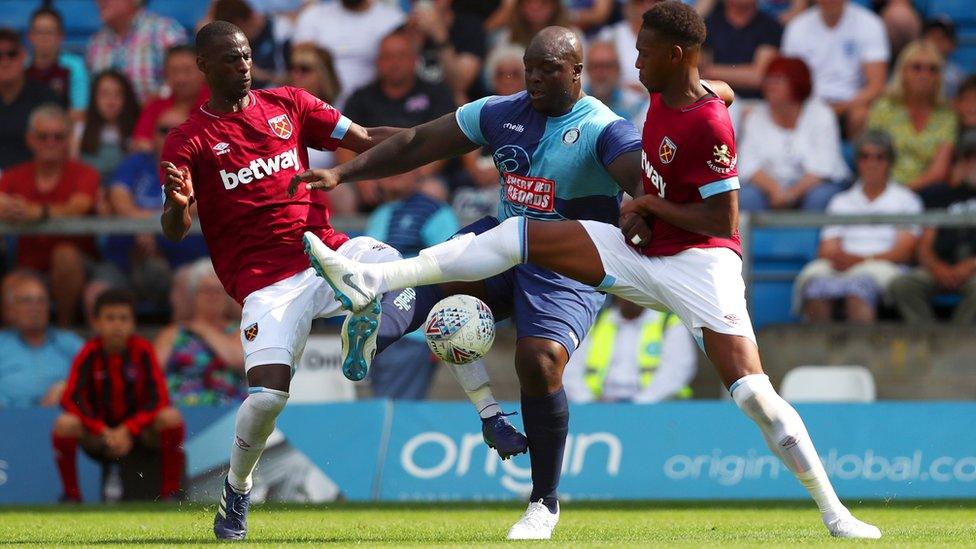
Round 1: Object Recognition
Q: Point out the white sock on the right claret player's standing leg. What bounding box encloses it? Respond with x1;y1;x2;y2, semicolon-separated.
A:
732;374;848;515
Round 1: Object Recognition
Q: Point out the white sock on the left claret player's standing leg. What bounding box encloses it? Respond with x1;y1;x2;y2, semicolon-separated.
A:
227;388;288;494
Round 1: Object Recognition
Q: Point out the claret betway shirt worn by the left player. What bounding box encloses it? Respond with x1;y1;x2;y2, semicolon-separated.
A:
161;87;351;302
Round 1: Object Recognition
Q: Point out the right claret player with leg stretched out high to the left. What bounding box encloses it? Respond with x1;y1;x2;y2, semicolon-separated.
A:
306;1;881;538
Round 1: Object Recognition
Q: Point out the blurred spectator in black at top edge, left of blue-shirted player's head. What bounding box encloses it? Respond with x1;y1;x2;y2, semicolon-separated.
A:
407;0;486;103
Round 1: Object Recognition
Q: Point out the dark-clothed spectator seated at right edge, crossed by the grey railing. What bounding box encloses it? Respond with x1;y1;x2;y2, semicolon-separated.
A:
891;134;976;325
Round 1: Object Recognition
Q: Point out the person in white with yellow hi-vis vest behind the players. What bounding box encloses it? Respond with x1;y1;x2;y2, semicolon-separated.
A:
564;298;698;404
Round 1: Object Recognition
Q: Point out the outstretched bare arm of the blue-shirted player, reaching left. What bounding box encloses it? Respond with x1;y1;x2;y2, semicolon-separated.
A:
288;112;478;195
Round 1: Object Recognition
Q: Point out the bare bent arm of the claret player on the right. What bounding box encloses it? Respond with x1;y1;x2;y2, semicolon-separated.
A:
620;191;739;238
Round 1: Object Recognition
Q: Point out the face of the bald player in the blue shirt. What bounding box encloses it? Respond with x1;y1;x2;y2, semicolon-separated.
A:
523;50;583;116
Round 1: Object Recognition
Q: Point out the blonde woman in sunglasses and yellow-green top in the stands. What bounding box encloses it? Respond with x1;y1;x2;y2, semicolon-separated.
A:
868;41;956;192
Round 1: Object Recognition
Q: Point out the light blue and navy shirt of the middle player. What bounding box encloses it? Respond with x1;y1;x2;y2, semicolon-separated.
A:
456;92;640;225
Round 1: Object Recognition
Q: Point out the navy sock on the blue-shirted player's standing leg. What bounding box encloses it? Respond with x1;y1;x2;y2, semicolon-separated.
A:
522;389;569;513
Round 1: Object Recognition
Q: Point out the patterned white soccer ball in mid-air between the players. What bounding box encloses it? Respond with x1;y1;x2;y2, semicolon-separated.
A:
424;295;495;364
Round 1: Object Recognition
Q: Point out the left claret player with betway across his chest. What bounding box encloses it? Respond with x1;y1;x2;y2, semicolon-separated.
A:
161;21;399;539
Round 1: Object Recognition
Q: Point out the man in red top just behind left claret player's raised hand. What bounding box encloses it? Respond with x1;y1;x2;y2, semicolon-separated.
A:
132;44;210;151
